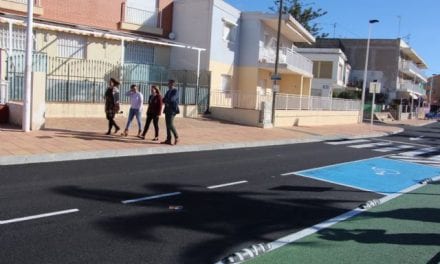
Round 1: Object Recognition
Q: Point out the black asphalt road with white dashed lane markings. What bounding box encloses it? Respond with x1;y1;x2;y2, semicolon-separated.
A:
0;124;440;264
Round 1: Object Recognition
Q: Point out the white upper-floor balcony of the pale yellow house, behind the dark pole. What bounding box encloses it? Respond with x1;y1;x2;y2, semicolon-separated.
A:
259;47;313;77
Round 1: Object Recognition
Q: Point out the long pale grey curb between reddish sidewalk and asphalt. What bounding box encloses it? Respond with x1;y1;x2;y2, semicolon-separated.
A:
0;128;404;166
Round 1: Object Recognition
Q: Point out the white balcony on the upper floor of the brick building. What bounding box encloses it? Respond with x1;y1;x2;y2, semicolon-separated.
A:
119;2;163;35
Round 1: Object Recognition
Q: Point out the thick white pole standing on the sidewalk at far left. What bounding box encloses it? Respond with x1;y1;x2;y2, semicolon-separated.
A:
22;0;34;132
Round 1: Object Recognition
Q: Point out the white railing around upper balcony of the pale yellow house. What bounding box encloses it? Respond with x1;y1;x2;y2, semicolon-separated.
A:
260;47;313;74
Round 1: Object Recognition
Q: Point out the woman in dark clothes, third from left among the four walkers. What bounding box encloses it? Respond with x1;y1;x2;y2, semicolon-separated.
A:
139;85;162;141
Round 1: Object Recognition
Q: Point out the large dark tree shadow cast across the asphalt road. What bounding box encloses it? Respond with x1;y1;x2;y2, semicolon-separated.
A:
53;184;371;263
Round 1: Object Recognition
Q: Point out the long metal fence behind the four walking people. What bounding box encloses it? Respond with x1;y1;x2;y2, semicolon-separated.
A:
8;54;210;112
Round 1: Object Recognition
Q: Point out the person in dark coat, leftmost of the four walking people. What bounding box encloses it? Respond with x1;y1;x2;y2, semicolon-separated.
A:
104;78;120;135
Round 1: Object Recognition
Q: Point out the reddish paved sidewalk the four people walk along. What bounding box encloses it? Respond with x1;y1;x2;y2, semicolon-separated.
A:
0;117;430;165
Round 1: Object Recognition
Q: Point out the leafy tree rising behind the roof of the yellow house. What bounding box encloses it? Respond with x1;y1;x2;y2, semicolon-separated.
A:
271;0;328;38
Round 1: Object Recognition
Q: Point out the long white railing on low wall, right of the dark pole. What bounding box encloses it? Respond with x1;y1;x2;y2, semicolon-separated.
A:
275;94;361;111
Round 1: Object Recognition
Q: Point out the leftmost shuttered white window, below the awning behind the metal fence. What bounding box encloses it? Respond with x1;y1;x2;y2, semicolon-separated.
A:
57;34;87;59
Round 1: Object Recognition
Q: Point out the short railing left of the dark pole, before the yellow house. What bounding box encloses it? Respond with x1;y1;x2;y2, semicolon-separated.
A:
210;90;272;110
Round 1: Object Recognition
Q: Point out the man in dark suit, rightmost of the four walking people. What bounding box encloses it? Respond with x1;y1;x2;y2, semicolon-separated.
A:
161;80;180;145
